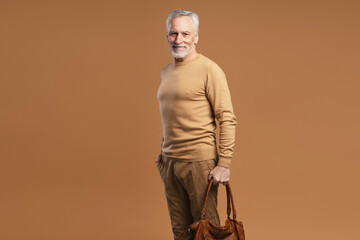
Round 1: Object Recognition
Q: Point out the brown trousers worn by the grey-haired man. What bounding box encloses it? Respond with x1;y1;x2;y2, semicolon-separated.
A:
157;155;220;240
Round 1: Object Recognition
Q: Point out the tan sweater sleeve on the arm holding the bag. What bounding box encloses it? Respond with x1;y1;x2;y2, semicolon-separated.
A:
205;63;237;168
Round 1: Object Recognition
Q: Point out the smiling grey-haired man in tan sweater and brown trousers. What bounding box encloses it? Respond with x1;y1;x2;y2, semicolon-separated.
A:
155;10;237;239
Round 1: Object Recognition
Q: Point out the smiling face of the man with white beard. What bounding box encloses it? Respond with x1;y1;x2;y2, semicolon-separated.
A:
167;16;199;59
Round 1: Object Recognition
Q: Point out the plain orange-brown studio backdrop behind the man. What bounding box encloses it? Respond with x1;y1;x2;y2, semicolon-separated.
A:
0;0;360;240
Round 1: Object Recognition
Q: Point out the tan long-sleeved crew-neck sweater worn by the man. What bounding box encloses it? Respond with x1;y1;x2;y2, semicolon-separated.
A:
157;54;237;167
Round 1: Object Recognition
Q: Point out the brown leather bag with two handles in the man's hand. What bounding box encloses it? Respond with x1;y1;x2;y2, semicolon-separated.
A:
181;179;245;240
